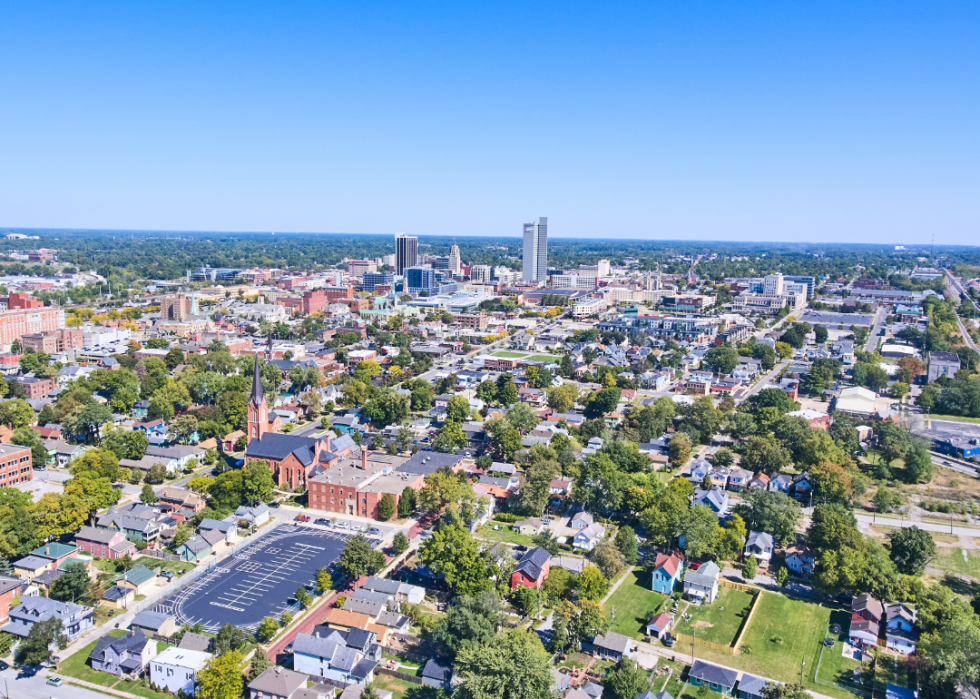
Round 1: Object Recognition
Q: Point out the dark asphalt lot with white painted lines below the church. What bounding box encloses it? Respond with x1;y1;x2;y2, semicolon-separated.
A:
153;524;348;633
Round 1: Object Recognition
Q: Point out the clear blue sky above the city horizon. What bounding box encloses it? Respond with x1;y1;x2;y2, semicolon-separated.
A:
0;0;980;244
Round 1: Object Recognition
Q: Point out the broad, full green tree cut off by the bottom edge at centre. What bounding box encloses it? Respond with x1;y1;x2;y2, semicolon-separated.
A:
453;629;553;699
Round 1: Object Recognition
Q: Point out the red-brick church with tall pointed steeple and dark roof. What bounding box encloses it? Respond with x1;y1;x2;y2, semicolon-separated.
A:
245;354;360;490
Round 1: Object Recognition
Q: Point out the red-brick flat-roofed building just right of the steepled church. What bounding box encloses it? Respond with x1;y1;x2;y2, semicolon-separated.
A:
309;449;425;517
